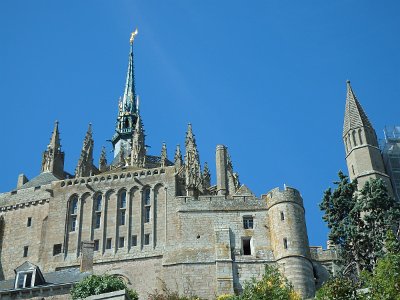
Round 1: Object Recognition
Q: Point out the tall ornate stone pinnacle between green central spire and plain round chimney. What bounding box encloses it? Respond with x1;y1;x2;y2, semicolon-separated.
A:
185;123;202;195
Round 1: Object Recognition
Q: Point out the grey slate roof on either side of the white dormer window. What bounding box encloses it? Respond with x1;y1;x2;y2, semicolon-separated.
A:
0;268;91;292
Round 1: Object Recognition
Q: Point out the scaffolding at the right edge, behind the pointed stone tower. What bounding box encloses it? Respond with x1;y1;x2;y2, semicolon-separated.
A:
382;126;400;201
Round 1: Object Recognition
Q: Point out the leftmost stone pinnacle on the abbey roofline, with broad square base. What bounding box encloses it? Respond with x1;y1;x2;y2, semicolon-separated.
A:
41;121;64;178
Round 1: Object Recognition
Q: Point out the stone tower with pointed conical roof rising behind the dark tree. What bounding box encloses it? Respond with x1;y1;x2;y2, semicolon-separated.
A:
343;81;393;194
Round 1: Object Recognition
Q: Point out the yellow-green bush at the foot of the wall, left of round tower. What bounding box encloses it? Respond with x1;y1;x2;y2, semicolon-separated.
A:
235;265;301;300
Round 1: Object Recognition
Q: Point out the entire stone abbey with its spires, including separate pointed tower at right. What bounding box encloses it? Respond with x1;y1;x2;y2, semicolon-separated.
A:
0;31;396;299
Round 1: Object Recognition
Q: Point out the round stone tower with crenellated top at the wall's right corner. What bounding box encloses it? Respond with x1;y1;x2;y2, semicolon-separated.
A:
264;187;315;298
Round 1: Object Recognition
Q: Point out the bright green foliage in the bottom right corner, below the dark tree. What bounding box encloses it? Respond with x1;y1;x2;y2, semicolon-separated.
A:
362;231;400;300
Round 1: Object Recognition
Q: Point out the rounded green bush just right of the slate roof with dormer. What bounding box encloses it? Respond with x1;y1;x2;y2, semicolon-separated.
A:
71;274;139;300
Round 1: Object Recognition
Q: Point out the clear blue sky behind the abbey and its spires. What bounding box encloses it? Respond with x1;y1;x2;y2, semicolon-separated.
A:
0;0;400;246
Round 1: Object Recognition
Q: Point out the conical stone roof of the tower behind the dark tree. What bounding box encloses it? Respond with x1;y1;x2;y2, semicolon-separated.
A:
343;80;373;136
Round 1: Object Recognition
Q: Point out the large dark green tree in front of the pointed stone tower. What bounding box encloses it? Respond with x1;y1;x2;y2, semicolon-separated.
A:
320;172;400;275
